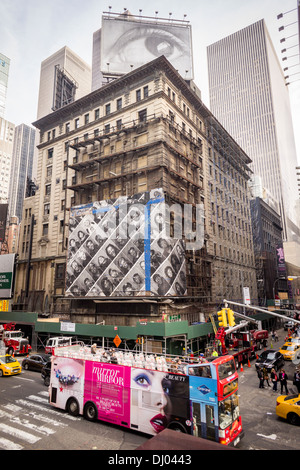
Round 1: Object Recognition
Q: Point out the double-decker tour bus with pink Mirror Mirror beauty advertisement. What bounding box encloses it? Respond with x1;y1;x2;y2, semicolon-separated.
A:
49;345;243;445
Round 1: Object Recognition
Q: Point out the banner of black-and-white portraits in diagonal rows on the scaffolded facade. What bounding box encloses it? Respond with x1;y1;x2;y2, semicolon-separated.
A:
66;189;186;297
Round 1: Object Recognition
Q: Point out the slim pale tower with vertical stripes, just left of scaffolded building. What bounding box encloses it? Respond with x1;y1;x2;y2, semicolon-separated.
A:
8;124;35;221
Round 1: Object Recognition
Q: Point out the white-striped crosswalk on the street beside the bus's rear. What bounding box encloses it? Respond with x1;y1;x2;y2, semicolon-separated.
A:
0;391;80;450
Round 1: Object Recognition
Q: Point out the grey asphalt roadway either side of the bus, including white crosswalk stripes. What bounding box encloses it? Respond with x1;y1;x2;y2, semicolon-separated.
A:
0;329;300;451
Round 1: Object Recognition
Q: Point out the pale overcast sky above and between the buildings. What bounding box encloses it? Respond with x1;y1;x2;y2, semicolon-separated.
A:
0;0;300;165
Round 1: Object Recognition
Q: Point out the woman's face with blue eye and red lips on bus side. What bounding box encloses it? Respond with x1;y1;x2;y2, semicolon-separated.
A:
131;369;169;434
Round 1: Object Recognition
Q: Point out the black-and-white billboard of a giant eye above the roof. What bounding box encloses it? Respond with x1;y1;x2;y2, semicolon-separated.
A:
100;17;194;80
